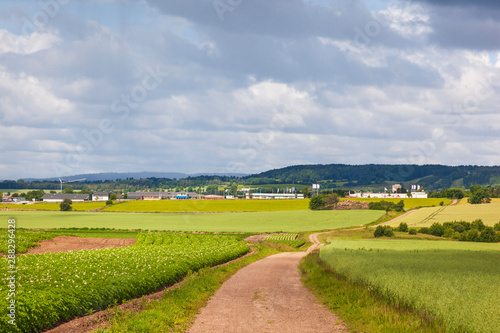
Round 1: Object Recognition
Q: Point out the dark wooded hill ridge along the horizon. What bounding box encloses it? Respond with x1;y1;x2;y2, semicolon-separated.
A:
0;164;500;191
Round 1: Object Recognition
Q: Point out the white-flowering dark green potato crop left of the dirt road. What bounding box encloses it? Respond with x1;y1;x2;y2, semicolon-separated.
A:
0;233;249;332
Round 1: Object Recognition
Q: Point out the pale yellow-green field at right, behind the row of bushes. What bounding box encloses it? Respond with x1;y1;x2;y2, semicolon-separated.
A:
389;203;500;227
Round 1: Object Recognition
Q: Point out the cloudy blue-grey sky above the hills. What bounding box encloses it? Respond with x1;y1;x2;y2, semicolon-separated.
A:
0;0;500;179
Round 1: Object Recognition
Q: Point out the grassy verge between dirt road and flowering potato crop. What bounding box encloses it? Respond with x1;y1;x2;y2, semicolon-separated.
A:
96;245;280;332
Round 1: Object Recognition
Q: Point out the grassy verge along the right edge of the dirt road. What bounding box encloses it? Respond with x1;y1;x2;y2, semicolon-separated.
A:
300;251;444;333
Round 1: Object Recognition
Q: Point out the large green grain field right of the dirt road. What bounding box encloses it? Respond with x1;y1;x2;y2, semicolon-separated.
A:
320;240;500;332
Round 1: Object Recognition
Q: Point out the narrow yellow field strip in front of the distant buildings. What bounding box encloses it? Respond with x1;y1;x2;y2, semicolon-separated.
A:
105;199;309;213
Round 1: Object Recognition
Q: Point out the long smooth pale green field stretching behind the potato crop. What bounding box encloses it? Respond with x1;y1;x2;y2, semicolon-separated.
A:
0;210;385;232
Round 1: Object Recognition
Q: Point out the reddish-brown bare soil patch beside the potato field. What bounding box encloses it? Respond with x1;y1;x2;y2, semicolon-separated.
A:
27;236;135;254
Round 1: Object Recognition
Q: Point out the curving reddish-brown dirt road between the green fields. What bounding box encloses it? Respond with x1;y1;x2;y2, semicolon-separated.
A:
189;233;348;333
